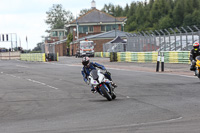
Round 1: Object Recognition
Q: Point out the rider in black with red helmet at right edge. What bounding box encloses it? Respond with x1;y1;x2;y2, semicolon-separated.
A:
190;42;200;71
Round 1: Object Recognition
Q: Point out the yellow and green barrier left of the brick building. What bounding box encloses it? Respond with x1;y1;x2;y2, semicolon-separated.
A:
20;53;46;62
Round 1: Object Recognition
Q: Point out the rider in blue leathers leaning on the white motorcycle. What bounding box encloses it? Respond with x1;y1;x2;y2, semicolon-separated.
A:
81;56;117;92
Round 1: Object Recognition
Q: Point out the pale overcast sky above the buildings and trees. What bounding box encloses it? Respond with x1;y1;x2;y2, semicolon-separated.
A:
0;0;142;49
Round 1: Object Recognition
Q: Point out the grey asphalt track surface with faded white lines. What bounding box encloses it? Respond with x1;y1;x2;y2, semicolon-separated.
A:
0;57;200;133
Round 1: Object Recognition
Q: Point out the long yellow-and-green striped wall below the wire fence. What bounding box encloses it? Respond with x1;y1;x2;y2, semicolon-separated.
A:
95;51;190;64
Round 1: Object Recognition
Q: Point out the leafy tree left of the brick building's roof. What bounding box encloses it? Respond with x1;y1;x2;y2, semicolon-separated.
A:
45;4;74;29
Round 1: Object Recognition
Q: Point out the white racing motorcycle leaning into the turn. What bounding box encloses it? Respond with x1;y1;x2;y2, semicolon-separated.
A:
88;69;116;101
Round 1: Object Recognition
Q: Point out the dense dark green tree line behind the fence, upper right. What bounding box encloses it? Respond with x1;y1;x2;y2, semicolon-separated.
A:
102;0;200;32
